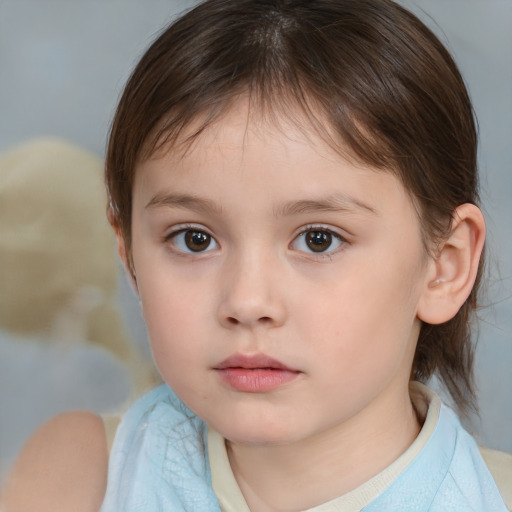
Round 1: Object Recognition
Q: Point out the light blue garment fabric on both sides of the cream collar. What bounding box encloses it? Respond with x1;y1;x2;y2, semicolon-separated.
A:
102;385;507;512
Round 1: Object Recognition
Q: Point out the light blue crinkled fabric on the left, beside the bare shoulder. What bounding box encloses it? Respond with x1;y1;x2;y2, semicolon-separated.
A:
101;385;220;512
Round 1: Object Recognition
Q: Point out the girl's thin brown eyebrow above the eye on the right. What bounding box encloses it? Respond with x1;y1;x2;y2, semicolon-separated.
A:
275;194;377;216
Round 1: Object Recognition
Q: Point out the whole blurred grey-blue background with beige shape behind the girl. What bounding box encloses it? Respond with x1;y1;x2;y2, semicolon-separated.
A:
0;0;512;482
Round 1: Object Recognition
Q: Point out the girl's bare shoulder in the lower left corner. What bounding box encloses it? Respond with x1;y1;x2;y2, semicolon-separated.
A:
1;411;108;512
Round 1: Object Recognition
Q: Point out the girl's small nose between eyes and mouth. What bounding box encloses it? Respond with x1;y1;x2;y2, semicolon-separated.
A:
218;250;287;329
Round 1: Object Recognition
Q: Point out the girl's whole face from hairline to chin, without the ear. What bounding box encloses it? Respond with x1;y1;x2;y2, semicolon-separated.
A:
128;108;430;444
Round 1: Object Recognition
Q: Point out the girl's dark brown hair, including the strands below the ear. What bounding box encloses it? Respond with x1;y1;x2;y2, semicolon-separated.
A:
106;0;482;412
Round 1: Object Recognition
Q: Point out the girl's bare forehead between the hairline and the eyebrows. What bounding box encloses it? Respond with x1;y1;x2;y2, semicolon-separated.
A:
135;102;416;222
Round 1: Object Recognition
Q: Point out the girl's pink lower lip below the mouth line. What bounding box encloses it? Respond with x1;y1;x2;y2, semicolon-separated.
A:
217;368;299;393
